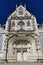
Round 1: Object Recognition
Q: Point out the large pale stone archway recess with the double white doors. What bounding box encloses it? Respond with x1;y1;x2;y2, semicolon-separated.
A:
7;36;36;61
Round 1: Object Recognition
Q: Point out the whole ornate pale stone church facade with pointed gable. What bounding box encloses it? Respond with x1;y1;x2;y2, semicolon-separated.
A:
0;5;43;62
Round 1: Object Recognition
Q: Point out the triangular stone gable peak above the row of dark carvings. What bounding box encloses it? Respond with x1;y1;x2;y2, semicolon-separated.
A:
9;5;33;18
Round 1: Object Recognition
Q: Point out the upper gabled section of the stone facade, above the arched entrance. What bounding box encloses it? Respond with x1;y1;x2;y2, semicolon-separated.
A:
6;5;37;31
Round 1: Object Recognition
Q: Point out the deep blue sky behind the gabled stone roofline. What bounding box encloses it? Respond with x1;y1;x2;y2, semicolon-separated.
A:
0;0;43;24
